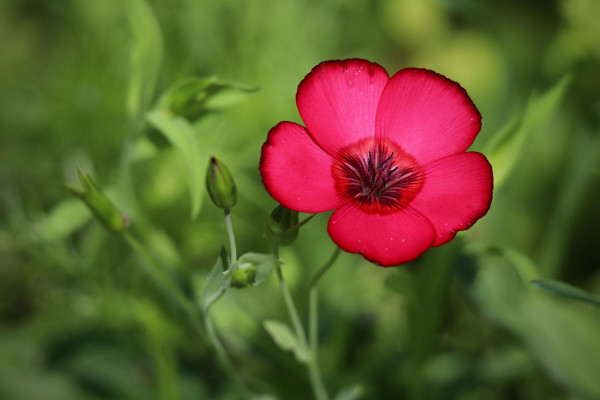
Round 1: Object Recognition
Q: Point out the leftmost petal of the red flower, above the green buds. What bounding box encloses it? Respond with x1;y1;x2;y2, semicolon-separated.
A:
259;122;343;213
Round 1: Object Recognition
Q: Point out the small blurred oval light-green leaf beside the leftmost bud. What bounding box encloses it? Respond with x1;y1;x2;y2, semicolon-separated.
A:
40;198;92;240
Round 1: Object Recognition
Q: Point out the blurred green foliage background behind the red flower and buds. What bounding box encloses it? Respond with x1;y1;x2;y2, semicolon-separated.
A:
0;0;600;400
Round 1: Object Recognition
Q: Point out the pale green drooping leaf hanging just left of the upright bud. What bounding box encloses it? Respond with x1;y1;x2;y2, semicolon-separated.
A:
147;110;208;219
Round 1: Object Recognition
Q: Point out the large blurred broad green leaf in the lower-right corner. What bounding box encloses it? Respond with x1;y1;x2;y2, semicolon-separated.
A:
471;250;600;399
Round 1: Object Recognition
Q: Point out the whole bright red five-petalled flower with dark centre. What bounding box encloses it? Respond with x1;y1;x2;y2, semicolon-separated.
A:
260;59;493;266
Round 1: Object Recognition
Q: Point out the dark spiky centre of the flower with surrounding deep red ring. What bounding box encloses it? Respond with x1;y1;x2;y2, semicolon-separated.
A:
333;139;424;214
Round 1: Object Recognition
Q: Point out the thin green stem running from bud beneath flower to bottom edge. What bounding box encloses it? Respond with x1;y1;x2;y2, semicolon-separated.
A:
273;240;329;400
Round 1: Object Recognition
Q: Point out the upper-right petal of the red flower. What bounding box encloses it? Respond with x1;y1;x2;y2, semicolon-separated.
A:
375;68;481;165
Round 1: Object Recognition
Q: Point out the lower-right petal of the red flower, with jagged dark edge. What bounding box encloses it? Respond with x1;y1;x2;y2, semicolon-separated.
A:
411;152;493;246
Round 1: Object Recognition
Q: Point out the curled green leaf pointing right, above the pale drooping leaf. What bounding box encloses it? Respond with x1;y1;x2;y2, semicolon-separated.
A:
159;77;257;121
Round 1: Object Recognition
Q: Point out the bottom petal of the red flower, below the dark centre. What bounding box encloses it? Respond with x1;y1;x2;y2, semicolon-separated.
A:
327;203;435;267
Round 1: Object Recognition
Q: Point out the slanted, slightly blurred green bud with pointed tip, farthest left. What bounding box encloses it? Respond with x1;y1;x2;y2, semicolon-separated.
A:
67;170;129;233
